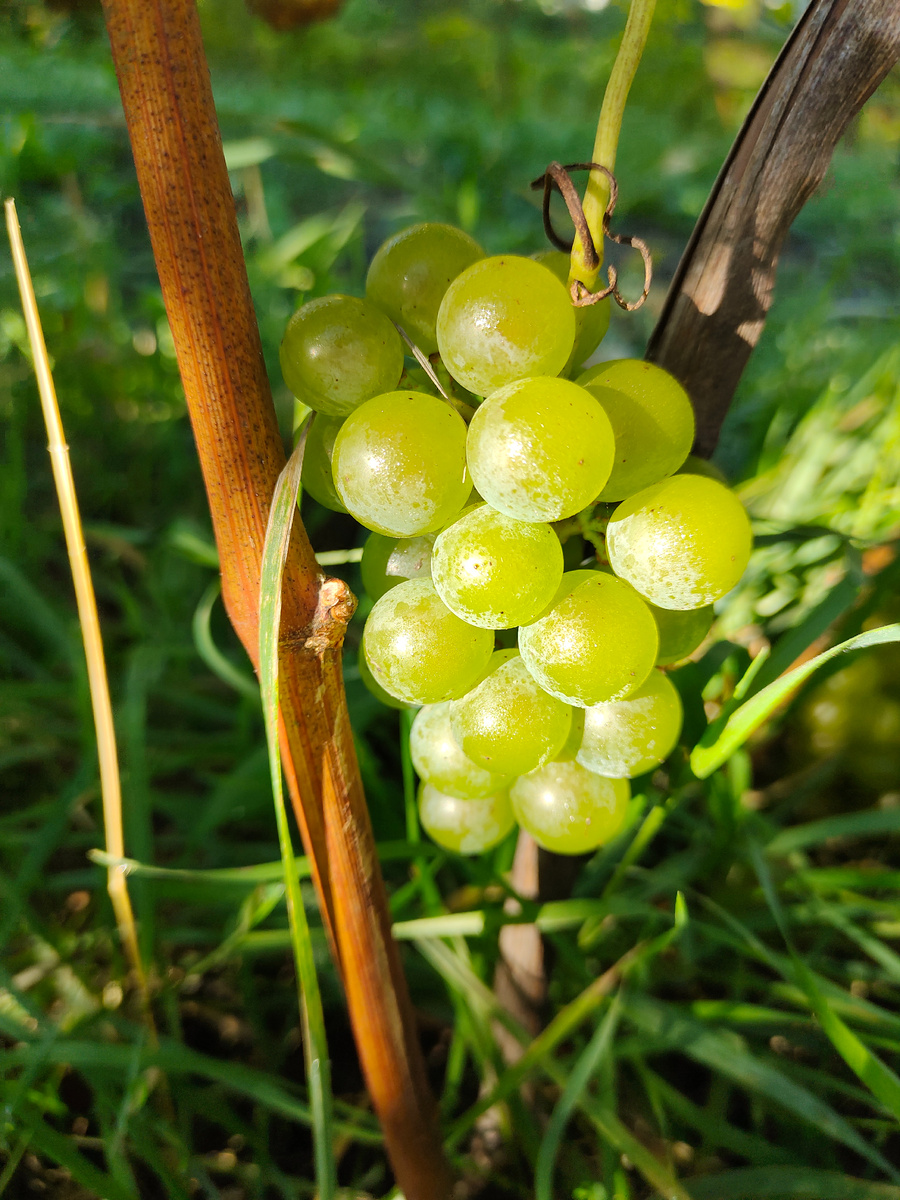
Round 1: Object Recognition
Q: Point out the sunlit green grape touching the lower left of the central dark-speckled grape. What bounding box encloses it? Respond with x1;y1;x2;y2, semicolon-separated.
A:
362;580;493;704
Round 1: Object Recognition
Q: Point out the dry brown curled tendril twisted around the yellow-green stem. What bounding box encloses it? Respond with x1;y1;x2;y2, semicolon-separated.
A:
532;162;653;312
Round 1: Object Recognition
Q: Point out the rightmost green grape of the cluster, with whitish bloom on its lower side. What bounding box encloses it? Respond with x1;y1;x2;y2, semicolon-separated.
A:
606;475;752;608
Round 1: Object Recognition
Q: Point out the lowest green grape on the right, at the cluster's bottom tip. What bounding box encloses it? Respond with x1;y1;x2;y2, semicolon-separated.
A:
509;761;631;854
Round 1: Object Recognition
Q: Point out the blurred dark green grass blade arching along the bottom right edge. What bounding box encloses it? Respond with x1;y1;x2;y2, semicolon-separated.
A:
688;1166;900;1200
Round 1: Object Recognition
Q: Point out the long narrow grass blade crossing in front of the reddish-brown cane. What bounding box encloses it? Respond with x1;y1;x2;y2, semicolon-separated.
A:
259;425;336;1200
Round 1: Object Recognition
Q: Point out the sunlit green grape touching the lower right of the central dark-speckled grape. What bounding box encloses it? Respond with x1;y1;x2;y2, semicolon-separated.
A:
518;571;659;708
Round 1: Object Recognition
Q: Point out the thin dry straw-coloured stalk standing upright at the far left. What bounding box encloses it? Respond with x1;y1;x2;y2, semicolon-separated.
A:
5;200;152;1008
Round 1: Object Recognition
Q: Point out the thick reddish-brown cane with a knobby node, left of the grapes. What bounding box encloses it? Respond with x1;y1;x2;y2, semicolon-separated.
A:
104;0;450;1200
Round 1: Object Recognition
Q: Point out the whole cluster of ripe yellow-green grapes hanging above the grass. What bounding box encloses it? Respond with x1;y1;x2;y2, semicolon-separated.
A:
281;224;751;853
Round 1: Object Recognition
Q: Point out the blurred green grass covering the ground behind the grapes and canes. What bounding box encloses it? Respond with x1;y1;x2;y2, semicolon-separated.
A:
0;0;900;1200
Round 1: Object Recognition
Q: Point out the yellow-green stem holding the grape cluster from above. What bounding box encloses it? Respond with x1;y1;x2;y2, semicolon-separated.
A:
570;0;656;290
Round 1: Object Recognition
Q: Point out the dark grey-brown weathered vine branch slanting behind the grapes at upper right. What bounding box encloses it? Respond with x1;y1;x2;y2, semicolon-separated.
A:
647;0;900;456
